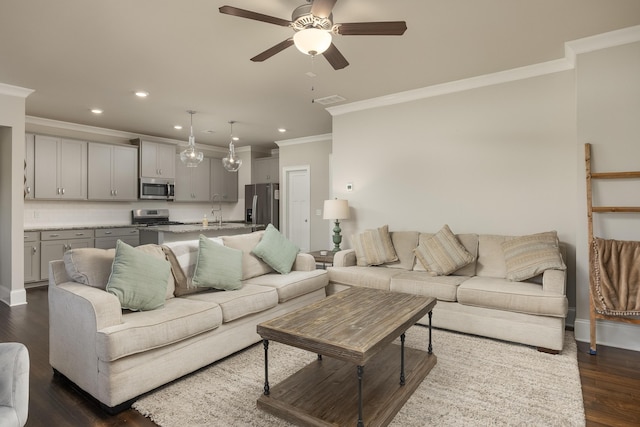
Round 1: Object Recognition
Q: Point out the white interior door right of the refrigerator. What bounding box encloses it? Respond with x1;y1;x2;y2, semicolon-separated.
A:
285;167;311;252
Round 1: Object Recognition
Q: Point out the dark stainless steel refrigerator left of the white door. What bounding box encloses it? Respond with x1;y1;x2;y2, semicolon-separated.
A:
244;184;280;230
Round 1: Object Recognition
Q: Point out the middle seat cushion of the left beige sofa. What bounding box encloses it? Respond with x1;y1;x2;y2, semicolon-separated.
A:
185;283;278;323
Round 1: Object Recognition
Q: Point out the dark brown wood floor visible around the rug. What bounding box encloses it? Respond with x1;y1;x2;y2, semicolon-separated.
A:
0;287;640;427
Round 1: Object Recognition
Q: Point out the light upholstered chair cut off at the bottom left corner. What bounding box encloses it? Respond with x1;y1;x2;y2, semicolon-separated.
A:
0;342;29;427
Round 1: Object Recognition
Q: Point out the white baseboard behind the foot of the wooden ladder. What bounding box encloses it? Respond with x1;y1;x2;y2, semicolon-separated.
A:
574;319;640;351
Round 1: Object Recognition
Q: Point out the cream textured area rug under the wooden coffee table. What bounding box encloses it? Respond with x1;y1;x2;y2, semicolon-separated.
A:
133;326;585;427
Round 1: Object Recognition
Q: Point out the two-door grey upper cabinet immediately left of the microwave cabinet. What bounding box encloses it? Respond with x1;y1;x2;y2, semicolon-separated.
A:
89;142;138;201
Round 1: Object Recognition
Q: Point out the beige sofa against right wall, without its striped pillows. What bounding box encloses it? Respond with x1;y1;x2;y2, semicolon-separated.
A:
327;231;568;352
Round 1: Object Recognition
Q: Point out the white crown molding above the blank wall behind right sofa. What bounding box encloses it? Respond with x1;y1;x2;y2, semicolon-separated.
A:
326;25;640;116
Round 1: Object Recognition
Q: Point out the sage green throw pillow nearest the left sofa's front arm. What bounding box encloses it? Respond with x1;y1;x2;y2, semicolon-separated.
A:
106;240;171;311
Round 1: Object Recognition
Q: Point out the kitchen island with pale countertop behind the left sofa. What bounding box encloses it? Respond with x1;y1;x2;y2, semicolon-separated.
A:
140;222;264;245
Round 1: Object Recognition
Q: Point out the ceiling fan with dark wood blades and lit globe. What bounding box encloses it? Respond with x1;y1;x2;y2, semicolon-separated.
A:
219;0;407;70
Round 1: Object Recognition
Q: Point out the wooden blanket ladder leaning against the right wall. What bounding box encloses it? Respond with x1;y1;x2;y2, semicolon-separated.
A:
584;143;640;354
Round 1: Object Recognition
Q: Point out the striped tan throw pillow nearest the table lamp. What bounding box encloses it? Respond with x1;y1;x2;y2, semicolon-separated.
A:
351;225;398;267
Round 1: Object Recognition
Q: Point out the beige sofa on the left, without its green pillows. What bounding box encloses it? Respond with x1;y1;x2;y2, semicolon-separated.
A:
49;232;328;413
